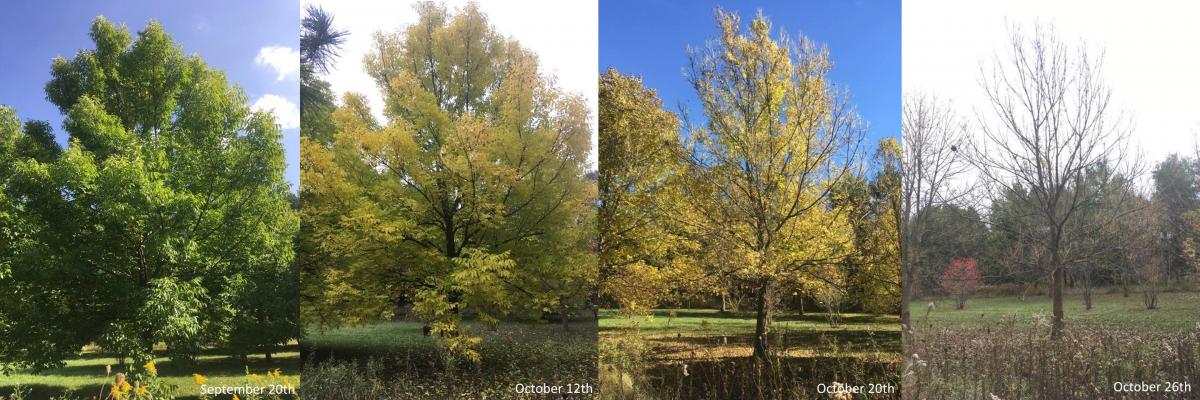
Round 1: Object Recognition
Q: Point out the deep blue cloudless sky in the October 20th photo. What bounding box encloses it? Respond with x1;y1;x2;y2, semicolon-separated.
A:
600;0;901;151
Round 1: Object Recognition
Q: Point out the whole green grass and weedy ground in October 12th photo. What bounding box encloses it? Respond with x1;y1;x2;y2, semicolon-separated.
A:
301;321;596;399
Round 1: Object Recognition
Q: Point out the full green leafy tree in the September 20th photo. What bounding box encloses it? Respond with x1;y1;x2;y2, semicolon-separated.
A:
0;17;299;368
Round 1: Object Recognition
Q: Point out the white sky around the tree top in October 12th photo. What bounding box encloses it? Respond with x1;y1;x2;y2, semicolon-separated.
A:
302;0;598;166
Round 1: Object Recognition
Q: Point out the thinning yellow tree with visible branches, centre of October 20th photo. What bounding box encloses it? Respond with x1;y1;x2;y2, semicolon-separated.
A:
684;10;862;359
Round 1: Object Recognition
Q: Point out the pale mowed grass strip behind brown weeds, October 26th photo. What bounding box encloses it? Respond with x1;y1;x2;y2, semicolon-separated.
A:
912;288;1200;333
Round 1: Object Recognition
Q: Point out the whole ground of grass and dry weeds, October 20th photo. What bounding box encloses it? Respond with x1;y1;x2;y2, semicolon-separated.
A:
600;310;900;399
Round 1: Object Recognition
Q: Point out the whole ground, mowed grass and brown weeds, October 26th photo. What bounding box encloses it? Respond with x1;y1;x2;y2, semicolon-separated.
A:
904;291;1200;400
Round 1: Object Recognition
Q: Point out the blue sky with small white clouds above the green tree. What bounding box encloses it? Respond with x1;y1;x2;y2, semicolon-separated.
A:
0;0;300;190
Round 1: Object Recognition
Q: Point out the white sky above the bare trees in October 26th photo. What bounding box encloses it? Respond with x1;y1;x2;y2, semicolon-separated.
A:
904;0;1200;174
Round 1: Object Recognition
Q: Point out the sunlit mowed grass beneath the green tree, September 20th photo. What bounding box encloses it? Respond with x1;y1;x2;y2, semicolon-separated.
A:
0;348;300;399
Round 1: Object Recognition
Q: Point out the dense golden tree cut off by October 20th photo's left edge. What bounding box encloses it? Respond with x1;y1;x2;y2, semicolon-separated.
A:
598;68;679;309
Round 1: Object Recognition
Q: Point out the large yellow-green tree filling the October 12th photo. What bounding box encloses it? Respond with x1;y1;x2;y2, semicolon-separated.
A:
301;2;598;341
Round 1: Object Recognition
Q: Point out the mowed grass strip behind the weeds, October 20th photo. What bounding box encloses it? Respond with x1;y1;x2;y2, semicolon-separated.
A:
600;309;900;359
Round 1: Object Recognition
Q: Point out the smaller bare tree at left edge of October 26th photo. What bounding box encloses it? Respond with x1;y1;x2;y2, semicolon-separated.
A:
900;94;966;327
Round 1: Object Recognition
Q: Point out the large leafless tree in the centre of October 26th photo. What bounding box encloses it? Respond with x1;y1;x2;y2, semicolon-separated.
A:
968;25;1136;338
